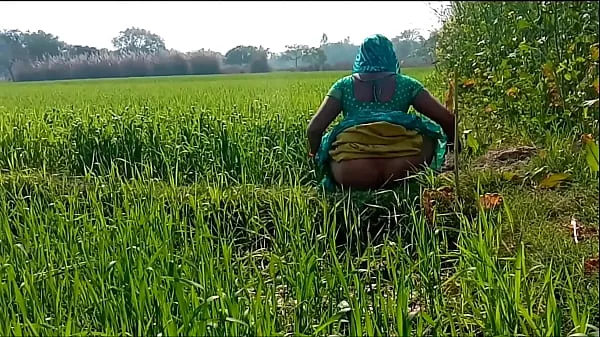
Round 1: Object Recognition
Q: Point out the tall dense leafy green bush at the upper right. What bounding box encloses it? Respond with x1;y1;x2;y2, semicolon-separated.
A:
436;1;599;143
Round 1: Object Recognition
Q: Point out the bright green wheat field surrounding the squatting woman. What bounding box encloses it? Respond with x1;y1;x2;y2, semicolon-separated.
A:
0;69;598;336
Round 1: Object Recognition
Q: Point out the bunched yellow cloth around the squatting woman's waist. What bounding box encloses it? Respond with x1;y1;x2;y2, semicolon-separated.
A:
329;122;423;162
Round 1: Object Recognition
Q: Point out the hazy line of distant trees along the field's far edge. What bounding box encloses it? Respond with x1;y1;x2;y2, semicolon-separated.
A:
0;27;437;81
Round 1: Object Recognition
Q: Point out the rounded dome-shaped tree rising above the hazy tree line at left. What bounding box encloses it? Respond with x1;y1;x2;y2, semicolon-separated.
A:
112;27;166;54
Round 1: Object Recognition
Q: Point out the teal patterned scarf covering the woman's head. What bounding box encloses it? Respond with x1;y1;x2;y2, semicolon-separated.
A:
352;34;400;74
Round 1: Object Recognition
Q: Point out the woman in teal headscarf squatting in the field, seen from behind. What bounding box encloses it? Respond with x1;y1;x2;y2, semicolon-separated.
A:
307;34;455;190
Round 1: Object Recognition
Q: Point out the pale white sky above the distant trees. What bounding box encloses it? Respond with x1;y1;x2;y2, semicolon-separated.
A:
0;1;442;53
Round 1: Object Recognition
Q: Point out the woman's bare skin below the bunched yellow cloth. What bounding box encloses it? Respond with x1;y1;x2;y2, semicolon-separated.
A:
331;137;434;189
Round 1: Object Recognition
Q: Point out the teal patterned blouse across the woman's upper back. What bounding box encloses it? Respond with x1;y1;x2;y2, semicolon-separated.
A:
328;73;423;117
